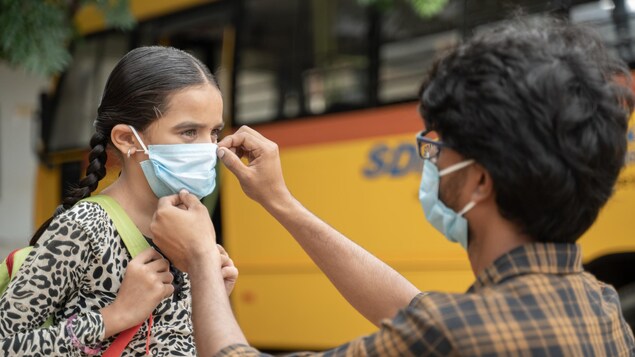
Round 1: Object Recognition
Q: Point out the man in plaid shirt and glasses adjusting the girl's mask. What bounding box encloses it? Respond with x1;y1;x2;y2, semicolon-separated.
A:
152;20;635;356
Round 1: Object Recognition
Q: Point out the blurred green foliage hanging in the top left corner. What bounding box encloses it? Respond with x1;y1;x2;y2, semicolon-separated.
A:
0;0;135;76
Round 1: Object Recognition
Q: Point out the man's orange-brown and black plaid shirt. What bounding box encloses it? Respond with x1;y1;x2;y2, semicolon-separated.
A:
219;243;635;356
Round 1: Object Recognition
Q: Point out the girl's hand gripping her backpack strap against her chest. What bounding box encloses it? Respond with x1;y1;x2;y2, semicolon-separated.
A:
100;248;174;338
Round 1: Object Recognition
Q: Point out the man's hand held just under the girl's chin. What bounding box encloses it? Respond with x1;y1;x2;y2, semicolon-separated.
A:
150;191;222;272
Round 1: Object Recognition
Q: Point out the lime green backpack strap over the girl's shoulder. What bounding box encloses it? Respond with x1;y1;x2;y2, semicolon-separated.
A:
80;195;150;258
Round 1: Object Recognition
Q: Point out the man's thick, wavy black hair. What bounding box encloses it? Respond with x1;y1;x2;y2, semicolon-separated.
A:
420;18;633;243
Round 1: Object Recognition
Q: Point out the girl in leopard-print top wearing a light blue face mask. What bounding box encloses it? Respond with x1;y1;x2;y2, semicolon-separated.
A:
0;47;237;356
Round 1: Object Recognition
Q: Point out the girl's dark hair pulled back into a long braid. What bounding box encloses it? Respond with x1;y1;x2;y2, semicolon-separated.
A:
30;46;218;245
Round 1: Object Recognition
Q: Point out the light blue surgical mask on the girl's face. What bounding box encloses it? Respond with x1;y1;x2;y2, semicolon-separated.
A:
130;126;217;199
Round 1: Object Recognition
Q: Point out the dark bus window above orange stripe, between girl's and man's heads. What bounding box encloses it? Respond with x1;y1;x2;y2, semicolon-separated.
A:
235;0;369;124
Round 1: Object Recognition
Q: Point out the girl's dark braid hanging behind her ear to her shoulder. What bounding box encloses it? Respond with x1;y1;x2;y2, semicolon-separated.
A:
29;132;108;245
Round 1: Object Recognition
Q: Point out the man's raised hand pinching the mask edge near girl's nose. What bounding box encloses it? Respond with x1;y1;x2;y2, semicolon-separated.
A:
218;126;291;207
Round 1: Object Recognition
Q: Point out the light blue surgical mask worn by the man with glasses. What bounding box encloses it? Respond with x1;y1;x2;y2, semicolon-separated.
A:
419;160;476;250
